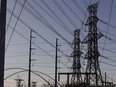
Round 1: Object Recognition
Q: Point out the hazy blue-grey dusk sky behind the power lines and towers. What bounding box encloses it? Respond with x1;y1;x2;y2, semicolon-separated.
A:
5;0;116;87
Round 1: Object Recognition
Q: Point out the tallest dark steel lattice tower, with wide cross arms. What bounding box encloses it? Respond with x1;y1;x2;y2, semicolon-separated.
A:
83;3;103;87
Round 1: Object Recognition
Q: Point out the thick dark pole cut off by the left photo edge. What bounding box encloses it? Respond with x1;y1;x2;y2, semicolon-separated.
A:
0;0;7;87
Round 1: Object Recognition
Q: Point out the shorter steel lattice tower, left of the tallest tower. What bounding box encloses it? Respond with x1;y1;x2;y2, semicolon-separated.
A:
71;29;82;87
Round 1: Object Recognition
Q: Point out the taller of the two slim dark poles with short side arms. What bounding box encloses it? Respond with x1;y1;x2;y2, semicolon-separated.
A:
28;30;32;87
